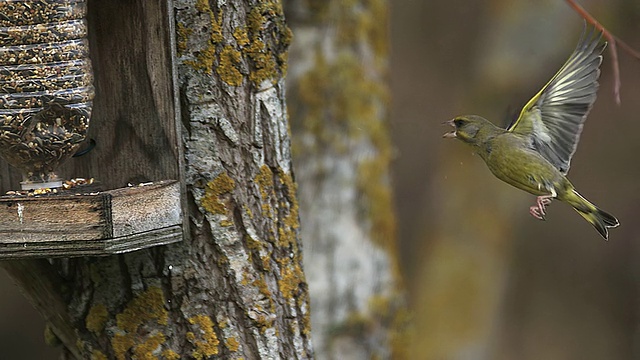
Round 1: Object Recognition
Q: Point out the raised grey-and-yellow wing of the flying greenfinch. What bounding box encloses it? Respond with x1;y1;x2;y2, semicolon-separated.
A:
507;27;607;174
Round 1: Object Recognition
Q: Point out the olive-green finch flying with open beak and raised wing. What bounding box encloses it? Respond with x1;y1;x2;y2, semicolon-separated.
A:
443;29;620;240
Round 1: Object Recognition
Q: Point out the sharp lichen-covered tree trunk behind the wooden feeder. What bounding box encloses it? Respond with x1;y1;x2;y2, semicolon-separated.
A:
0;0;313;359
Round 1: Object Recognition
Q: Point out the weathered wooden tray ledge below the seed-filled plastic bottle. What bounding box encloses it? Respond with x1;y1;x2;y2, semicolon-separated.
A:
0;181;183;259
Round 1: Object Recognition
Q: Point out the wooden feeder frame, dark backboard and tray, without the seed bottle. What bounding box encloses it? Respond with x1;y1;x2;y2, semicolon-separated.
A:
0;0;187;259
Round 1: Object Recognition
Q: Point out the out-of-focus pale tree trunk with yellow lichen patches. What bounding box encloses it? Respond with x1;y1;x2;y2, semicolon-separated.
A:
285;0;404;359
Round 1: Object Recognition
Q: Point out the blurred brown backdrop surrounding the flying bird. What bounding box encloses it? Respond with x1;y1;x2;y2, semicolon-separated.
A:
0;0;640;359
